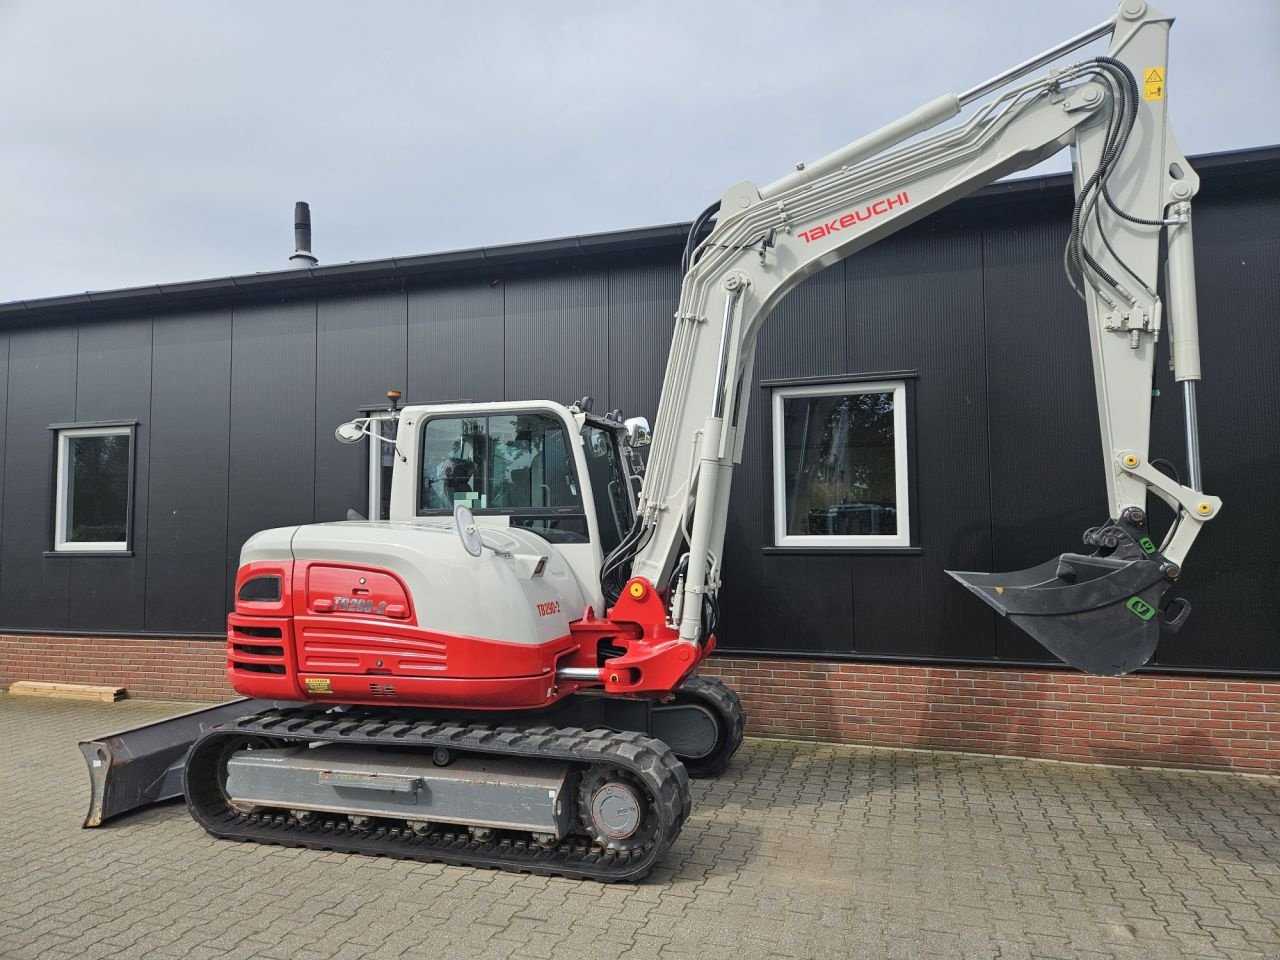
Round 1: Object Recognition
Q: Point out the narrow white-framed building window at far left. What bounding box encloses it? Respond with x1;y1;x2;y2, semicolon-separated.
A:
54;424;133;553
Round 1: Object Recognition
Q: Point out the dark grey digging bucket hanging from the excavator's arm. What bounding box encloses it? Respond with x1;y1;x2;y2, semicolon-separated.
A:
947;553;1170;677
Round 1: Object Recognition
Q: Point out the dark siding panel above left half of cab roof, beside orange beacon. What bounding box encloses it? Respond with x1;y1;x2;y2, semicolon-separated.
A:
404;283;504;402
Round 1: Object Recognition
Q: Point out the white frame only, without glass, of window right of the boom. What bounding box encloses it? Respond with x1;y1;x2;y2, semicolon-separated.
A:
773;380;911;549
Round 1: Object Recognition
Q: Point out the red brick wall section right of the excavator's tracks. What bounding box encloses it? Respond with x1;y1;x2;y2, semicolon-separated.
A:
703;658;1280;774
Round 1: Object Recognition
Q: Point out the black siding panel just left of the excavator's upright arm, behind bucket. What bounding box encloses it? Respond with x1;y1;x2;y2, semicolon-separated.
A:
984;204;1107;660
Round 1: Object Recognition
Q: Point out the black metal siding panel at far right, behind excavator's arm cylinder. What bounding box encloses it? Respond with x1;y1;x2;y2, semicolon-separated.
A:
1151;186;1280;669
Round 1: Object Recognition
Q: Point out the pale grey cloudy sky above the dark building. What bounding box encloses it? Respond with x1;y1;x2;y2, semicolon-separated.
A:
0;0;1280;301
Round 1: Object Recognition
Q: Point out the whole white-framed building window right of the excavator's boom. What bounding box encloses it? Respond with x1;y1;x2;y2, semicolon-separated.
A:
773;380;911;547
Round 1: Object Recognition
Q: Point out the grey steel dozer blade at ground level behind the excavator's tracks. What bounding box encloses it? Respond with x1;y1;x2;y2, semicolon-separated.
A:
79;700;279;827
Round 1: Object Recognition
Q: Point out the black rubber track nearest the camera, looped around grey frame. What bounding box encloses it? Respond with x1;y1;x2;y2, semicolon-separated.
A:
184;707;690;882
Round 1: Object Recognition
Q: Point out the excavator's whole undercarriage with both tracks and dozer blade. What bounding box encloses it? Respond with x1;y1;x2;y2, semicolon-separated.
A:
82;676;745;881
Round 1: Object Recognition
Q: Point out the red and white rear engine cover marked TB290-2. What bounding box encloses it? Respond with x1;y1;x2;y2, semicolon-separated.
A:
228;521;585;709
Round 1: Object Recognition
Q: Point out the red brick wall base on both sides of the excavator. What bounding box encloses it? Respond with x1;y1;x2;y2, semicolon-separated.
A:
0;635;1280;774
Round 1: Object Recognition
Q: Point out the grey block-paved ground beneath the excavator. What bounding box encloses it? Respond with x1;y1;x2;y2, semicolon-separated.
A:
0;695;1280;960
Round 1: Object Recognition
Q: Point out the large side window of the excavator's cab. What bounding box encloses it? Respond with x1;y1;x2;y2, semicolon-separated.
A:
417;413;588;543
